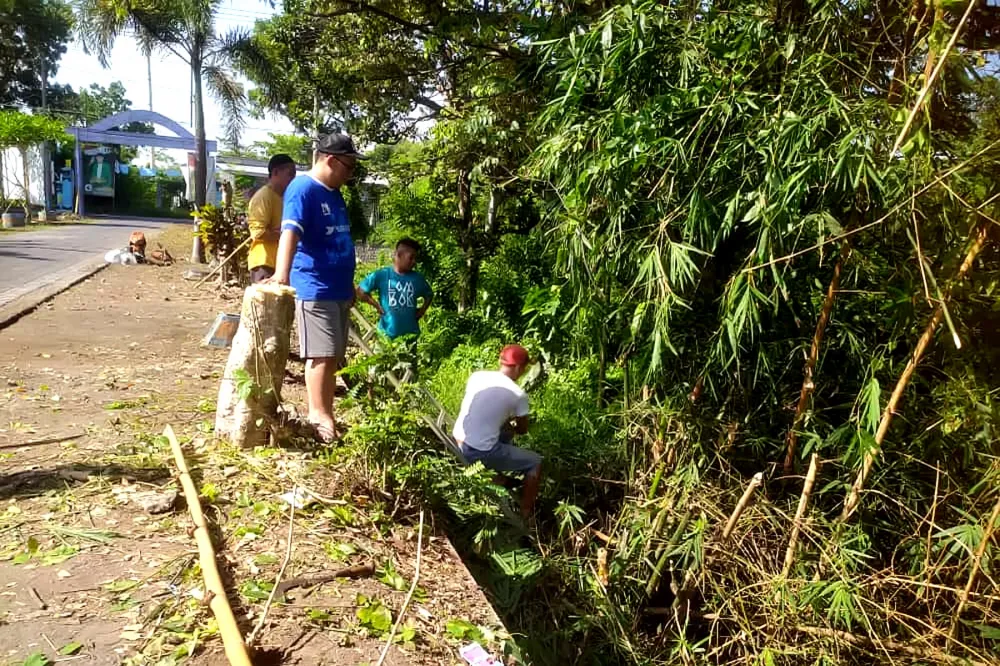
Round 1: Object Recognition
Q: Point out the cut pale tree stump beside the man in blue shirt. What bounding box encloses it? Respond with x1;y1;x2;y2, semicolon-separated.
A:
215;284;295;448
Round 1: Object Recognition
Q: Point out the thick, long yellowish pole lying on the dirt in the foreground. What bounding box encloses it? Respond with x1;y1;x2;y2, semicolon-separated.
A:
163;425;253;666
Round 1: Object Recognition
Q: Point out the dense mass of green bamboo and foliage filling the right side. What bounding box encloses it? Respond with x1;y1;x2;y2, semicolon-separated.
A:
251;0;1000;664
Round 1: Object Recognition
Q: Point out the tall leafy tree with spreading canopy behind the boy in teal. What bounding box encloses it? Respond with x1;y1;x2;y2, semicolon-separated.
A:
238;0;562;308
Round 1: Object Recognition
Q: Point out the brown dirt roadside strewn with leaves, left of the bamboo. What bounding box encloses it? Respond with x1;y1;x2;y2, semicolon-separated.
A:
0;230;503;666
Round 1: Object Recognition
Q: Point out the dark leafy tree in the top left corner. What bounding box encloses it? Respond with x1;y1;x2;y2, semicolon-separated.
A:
0;0;73;107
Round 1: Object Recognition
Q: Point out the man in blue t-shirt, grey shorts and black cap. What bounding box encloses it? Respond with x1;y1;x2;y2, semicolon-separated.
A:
274;134;364;442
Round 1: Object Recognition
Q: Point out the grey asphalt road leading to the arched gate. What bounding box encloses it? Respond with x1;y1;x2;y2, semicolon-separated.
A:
0;219;181;308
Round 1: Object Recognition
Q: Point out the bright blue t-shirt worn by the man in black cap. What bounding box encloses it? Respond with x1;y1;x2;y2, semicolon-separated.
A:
281;174;354;301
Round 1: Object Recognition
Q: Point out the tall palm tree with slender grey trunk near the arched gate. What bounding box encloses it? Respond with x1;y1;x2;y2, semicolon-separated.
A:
78;0;251;262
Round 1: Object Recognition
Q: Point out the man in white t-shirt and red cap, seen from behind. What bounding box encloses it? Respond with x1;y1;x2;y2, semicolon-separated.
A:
452;345;542;518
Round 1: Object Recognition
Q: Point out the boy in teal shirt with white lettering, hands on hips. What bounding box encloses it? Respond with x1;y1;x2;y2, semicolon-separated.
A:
358;238;434;340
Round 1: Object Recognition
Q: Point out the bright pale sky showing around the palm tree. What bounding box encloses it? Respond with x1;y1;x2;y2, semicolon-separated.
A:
55;0;293;152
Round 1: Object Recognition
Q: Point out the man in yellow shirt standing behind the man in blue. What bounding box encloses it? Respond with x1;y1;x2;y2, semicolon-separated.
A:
247;153;295;282
